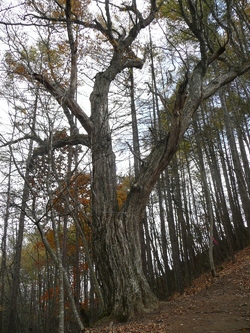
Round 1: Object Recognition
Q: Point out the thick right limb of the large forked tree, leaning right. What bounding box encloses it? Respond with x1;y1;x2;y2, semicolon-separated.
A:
122;61;250;220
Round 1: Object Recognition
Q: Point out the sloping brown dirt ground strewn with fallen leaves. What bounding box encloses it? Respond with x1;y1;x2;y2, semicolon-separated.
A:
86;247;250;333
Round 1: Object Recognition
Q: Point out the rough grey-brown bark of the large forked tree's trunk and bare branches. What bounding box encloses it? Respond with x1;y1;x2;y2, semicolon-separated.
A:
2;0;250;320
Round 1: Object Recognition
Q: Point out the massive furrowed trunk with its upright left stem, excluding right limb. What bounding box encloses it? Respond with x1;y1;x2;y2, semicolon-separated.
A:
91;73;158;320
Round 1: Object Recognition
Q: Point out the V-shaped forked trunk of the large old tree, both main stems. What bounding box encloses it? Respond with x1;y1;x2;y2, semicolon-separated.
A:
90;55;250;320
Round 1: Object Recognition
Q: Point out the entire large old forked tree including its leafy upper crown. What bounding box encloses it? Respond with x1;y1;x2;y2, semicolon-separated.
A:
1;0;250;320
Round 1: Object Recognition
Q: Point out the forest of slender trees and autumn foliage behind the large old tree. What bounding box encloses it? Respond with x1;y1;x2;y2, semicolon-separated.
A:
0;0;250;333
